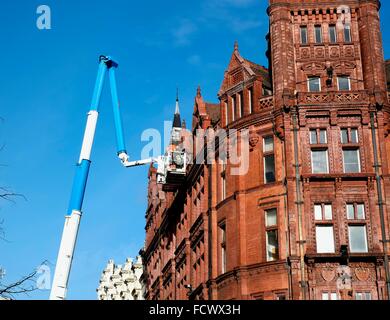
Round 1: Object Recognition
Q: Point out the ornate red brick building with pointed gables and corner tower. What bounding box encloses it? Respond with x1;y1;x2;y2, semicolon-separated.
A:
143;0;390;300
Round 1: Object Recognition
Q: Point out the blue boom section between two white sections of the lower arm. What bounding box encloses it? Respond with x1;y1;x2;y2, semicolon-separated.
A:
68;160;91;215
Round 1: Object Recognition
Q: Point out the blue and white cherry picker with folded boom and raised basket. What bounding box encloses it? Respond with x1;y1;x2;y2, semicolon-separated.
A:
50;55;186;300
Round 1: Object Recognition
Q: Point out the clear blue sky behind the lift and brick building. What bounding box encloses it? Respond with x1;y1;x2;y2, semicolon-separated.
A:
0;0;390;299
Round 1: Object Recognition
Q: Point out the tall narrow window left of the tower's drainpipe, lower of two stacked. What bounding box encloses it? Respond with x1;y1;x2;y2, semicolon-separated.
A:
265;209;279;261
